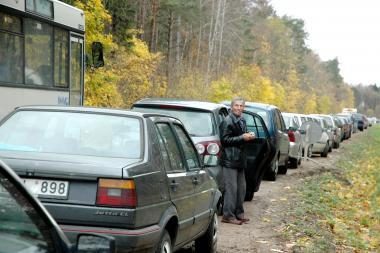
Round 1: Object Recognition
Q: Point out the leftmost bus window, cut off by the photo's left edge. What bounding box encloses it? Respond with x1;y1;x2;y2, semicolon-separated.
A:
0;12;24;83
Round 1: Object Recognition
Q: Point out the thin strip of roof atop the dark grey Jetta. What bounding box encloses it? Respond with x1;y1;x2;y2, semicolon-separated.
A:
11;105;176;119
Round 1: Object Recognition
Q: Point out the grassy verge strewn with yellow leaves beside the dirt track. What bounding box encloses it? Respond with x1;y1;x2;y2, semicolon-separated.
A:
283;125;380;252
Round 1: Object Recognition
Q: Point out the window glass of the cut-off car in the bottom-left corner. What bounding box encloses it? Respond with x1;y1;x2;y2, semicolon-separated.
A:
0;171;56;253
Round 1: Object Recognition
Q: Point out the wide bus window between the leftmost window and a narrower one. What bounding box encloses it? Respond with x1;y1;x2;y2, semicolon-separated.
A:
25;19;53;86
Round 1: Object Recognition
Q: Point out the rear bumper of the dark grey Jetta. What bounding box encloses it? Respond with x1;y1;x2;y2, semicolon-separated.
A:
60;225;162;253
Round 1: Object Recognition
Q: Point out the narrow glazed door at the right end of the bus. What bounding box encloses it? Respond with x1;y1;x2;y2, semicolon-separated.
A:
70;35;84;106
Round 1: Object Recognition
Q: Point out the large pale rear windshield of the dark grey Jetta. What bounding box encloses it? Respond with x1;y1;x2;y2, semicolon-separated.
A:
0;111;143;158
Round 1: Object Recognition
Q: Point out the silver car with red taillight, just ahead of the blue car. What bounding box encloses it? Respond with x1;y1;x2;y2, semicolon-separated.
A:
282;112;304;168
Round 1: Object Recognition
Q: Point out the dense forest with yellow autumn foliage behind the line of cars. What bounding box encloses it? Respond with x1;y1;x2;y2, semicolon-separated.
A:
64;0;380;117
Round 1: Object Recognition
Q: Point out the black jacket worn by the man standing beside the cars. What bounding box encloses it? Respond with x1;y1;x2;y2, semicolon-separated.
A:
220;113;247;169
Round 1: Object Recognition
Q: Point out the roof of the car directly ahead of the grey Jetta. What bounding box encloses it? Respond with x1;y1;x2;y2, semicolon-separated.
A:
133;98;227;111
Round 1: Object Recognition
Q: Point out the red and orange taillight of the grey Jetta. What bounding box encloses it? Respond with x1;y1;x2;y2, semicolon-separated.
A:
96;178;137;208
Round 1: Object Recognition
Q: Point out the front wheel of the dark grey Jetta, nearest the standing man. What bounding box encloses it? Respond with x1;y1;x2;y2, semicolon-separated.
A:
195;213;219;253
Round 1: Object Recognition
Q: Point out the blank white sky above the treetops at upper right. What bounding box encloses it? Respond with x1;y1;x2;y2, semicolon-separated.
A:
270;0;380;85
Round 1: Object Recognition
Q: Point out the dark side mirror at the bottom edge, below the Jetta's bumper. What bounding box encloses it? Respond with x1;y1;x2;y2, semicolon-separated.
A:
76;234;116;253
